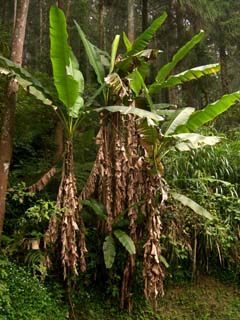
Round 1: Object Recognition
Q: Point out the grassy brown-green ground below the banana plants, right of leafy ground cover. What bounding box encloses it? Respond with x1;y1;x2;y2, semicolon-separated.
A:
76;277;240;320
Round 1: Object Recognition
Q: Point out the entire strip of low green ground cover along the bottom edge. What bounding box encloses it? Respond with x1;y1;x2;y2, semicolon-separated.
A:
0;257;240;320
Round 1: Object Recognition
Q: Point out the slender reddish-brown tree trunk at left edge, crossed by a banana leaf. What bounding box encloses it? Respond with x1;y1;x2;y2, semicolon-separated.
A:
0;0;29;236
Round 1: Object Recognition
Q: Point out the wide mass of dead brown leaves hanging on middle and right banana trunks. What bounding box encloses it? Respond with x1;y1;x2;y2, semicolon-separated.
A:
80;107;165;311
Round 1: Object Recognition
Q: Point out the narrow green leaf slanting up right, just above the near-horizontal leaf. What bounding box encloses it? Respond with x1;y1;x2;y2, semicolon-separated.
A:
154;31;204;88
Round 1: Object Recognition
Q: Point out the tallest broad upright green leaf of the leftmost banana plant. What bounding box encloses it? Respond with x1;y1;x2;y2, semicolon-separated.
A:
50;6;83;117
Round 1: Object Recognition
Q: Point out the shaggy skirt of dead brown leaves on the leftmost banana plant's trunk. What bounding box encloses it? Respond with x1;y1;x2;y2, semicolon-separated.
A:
45;140;87;278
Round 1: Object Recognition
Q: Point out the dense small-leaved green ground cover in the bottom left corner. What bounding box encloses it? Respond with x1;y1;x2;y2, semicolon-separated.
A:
0;256;66;320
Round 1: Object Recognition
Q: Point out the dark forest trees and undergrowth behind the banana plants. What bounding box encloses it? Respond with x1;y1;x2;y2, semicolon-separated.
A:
0;0;240;319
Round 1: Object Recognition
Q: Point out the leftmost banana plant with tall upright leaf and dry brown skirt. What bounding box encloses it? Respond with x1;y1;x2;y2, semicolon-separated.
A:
0;6;86;277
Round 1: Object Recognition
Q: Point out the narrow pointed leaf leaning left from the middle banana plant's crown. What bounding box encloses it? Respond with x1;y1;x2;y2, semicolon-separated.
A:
74;21;105;85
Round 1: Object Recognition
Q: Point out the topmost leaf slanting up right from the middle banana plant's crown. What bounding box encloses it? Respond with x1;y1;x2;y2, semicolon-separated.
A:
126;12;167;56
